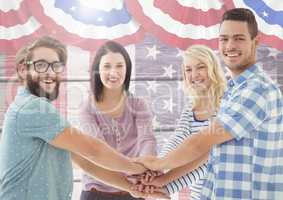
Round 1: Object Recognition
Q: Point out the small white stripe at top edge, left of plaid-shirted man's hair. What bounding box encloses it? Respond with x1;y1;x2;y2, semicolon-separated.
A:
177;0;223;12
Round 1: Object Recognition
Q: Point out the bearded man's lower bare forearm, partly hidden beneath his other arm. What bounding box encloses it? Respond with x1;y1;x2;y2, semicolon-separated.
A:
72;154;131;191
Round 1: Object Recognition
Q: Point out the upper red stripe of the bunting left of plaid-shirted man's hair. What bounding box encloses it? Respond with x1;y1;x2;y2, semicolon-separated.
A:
154;0;235;27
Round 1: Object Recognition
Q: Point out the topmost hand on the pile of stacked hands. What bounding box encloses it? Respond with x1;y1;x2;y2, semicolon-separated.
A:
132;156;163;171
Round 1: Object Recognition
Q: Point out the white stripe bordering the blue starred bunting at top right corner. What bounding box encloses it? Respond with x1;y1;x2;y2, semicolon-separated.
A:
233;0;283;40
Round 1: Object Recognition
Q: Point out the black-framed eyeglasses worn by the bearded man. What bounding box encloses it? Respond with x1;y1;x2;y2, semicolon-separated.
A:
26;60;65;73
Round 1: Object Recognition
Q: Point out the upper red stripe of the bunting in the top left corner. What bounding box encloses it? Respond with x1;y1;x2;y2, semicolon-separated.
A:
0;0;31;27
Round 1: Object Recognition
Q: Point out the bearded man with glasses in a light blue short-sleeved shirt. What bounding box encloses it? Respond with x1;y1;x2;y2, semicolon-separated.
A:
0;37;168;200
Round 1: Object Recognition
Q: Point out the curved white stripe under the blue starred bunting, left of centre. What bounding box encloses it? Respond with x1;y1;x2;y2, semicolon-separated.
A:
40;0;140;40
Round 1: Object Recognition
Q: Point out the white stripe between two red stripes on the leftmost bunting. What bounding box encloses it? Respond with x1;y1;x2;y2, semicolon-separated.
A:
0;17;41;40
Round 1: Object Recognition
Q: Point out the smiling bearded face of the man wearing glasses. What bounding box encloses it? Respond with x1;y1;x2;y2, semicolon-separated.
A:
26;47;60;100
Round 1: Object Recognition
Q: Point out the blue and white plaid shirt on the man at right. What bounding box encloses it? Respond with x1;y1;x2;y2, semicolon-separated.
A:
201;65;283;200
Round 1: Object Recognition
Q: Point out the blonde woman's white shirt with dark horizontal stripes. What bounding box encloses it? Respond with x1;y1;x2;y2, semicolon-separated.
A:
160;106;214;199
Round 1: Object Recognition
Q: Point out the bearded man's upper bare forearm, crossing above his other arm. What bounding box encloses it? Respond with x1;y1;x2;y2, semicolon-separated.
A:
53;128;145;174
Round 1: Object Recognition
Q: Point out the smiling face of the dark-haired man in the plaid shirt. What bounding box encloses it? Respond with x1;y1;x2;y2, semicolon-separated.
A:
219;20;258;75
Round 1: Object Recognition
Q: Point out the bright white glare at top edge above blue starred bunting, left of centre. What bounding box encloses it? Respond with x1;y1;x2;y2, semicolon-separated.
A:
80;0;123;12
